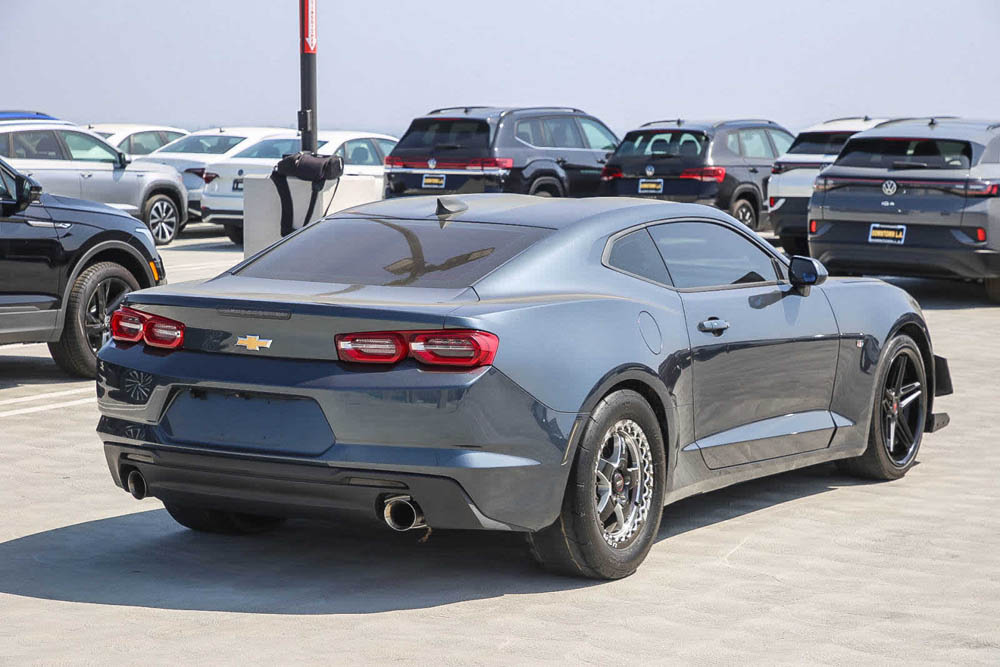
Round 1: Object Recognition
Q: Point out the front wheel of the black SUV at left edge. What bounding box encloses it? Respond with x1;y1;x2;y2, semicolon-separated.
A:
49;262;139;377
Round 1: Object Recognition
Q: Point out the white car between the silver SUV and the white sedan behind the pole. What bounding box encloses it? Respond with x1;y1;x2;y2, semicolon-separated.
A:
136;127;291;226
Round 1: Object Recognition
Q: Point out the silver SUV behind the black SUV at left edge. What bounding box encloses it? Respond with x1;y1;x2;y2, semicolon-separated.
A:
0;121;187;245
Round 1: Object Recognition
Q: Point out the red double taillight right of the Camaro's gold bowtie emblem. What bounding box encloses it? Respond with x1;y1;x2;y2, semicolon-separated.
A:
334;329;500;368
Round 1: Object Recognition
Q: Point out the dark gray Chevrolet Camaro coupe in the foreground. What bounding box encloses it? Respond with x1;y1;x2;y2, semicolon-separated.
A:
98;195;950;578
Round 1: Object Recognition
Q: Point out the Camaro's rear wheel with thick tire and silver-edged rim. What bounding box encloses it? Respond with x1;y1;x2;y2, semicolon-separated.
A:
528;390;666;579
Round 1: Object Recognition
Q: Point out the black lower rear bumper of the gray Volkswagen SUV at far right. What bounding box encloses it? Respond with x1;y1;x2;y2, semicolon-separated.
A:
809;222;1000;279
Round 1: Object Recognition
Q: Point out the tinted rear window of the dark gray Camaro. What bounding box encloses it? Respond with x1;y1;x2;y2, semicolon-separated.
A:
239;218;552;288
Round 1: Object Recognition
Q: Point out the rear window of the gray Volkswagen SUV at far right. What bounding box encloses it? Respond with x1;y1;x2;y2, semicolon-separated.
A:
836;138;972;169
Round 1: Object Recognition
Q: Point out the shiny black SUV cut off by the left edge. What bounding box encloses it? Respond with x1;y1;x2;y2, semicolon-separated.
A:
0;155;166;377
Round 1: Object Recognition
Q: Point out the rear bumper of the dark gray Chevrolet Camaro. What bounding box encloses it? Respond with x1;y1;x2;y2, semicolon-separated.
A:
97;344;586;530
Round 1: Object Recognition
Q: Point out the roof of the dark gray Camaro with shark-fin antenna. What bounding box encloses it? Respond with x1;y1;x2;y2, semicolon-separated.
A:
332;194;724;231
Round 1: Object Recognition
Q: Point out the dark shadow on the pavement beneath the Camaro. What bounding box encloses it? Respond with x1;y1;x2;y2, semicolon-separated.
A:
0;466;872;614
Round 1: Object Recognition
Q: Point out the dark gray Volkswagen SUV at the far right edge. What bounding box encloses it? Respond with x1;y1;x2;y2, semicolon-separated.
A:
809;118;1000;301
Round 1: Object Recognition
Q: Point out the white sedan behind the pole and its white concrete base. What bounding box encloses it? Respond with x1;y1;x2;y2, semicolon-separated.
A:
201;131;397;244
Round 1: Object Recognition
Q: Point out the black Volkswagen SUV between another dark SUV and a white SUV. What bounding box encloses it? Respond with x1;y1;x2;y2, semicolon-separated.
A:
601;118;794;229
